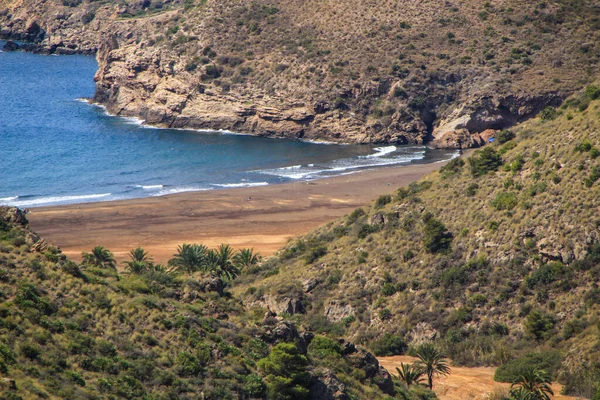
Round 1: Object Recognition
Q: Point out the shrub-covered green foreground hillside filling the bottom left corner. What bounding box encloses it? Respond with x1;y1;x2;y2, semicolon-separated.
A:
0;207;435;400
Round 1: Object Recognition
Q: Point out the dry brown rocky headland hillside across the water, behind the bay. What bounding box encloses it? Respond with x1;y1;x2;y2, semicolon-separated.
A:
0;0;600;147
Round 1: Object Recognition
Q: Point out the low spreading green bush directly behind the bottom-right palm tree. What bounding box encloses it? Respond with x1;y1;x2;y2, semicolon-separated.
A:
494;350;563;383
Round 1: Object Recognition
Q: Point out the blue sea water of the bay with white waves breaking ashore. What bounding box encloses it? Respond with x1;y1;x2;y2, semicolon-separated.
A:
0;42;454;207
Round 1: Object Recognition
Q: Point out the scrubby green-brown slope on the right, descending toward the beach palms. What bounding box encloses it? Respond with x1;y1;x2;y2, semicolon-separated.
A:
234;86;600;397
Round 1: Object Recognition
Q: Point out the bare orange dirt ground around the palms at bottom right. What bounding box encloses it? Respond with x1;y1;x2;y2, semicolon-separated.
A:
378;356;576;400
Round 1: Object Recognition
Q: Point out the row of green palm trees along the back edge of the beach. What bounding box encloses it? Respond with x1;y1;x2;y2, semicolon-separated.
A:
82;244;261;292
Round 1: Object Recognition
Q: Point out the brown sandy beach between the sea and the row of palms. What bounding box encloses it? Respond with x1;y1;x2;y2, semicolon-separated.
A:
28;163;450;263
